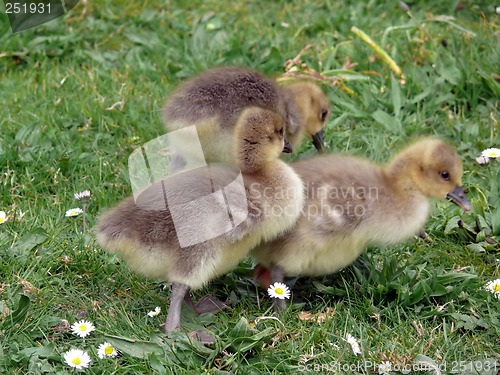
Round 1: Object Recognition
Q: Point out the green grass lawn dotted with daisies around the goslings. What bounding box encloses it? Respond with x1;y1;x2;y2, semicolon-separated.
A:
0;1;500;374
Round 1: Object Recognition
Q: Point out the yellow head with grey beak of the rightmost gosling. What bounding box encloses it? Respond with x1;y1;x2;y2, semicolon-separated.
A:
390;138;471;211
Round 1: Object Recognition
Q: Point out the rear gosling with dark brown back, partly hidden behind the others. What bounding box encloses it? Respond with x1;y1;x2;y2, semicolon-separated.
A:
163;67;330;164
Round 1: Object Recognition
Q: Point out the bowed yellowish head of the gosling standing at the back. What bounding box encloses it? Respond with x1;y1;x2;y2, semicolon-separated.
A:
285;81;330;152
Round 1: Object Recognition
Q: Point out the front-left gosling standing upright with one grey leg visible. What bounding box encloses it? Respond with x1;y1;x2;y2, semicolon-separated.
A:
95;107;304;332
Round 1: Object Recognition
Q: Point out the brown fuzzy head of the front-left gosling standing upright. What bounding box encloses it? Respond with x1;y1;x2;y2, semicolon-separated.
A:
234;107;292;173
